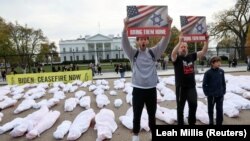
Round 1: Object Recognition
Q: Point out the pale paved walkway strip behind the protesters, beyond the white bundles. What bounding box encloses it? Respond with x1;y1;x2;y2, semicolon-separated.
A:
0;66;250;85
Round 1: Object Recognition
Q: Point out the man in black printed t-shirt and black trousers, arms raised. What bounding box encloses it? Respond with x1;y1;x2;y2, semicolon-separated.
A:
171;33;208;125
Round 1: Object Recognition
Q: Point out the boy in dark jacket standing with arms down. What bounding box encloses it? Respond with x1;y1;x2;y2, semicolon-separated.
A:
202;56;226;125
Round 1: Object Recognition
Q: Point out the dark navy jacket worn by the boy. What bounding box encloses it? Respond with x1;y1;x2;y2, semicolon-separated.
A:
202;68;226;97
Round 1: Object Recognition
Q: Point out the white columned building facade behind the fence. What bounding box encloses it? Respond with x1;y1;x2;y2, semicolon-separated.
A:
59;34;136;62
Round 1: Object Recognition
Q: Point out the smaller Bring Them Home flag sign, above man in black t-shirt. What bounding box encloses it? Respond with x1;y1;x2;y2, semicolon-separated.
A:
180;16;207;42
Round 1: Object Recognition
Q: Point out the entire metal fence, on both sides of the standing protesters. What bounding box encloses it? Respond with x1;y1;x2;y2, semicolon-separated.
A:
0;47;250;73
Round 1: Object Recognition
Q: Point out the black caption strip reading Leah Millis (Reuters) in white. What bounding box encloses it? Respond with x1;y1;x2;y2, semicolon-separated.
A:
152;125;250;141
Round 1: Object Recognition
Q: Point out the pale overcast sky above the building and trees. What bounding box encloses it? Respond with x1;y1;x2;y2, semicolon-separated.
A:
0;0;236;45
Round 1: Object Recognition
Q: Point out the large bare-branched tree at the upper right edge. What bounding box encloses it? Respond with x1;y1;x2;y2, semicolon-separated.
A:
209;0;250;59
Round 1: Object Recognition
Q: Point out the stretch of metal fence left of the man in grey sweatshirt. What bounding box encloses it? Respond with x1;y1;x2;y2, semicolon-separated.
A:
0;50;129;73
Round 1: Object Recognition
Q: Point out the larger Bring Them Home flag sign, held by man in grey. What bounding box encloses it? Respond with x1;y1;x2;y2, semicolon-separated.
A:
127;5;169;36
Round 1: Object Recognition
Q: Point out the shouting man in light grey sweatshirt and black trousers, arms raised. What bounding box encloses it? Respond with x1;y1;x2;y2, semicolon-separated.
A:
122;6;172;141
